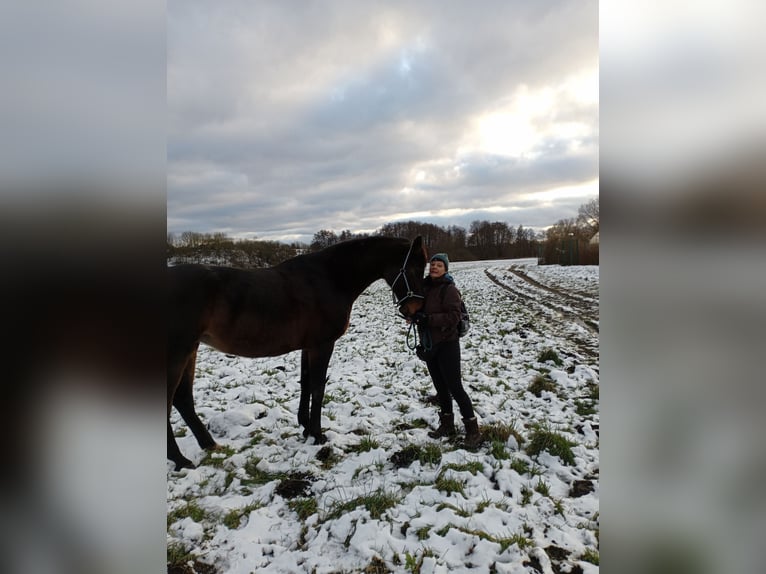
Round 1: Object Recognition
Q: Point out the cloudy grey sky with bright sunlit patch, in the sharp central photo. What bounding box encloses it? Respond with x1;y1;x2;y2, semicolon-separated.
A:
167;0;599;242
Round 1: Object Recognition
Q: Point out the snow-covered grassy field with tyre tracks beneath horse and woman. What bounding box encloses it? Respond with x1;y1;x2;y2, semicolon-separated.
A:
167;259;599;574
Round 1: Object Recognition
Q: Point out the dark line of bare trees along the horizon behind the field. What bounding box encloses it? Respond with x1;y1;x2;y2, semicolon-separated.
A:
167;198;599;267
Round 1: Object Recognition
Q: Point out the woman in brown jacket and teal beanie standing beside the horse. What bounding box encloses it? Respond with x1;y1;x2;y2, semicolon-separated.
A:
411;253;482;448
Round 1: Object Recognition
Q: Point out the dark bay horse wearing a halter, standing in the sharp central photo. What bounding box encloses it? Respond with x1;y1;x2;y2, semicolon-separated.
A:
167;237;427;469
